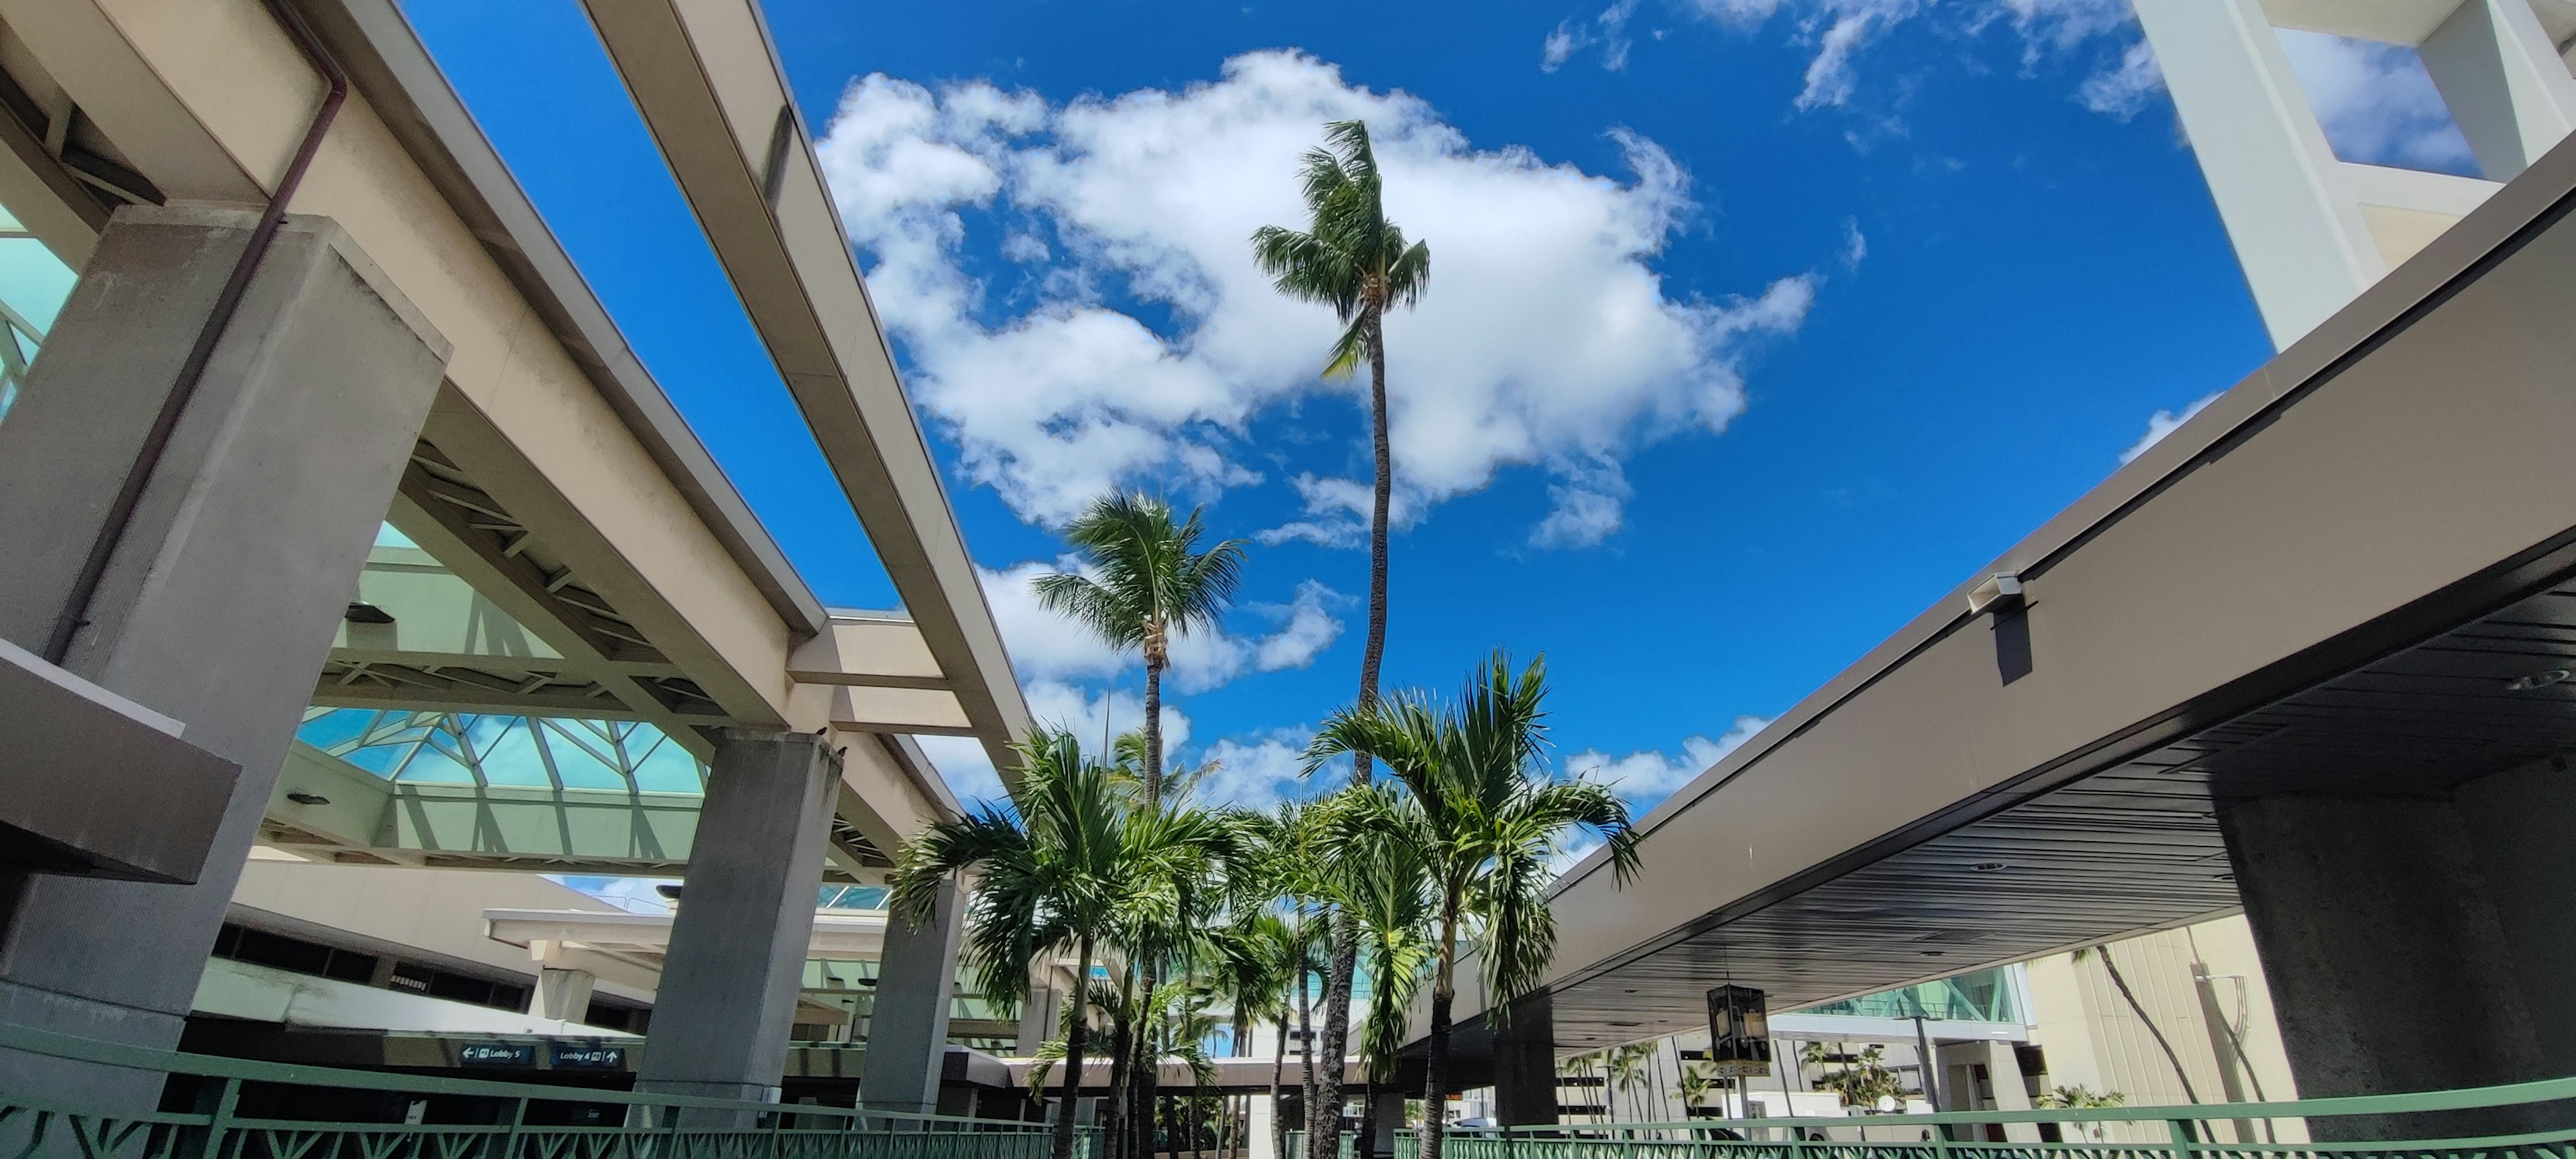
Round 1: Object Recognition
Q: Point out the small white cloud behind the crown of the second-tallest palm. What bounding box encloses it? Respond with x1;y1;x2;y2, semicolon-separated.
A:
976;556;1342;693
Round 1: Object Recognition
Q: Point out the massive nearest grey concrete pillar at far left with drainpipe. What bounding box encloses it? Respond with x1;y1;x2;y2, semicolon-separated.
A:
0;206;448;1110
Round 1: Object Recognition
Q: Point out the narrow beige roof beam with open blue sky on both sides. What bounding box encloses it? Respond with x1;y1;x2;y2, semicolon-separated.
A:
588;0;1028;767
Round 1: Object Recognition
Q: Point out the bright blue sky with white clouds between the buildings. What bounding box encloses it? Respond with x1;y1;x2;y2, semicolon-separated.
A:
391;0;2465;804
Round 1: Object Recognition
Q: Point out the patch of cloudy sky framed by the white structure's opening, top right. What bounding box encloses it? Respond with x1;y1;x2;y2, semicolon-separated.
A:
2279;28;2475;172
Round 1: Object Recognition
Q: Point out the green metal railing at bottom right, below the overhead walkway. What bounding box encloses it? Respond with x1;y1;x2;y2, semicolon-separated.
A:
1291;1079;2576;1159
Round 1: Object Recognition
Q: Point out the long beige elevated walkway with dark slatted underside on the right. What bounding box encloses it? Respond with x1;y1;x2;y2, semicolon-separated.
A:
1452;106;2576;1089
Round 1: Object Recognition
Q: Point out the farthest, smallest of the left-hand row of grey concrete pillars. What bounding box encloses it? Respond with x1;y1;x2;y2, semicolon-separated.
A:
858;881;966;1115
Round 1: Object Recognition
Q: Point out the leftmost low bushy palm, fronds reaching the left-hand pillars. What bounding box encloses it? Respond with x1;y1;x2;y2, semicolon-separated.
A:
886;729;1136;1159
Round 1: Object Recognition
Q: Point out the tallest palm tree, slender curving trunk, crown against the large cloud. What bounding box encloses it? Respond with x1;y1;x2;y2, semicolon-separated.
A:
1252;121;1432;1159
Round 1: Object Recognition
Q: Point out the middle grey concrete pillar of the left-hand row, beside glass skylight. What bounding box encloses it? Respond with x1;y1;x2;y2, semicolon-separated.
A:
636;729;840;1125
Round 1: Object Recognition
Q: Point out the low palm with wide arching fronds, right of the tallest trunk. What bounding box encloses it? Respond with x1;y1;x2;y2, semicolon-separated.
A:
1306;652;1638;1159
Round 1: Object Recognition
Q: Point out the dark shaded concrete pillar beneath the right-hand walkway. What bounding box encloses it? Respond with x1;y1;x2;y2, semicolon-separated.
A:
2218;785;2576;1138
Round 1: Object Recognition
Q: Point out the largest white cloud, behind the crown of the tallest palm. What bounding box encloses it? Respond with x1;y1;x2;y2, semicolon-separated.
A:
816;52;1813;543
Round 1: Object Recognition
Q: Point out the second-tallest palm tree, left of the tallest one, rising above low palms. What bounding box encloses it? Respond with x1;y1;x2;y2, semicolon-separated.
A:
1038;494;1244;809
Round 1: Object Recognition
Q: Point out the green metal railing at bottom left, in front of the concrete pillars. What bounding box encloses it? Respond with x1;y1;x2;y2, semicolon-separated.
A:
0;1022;1097;1159
